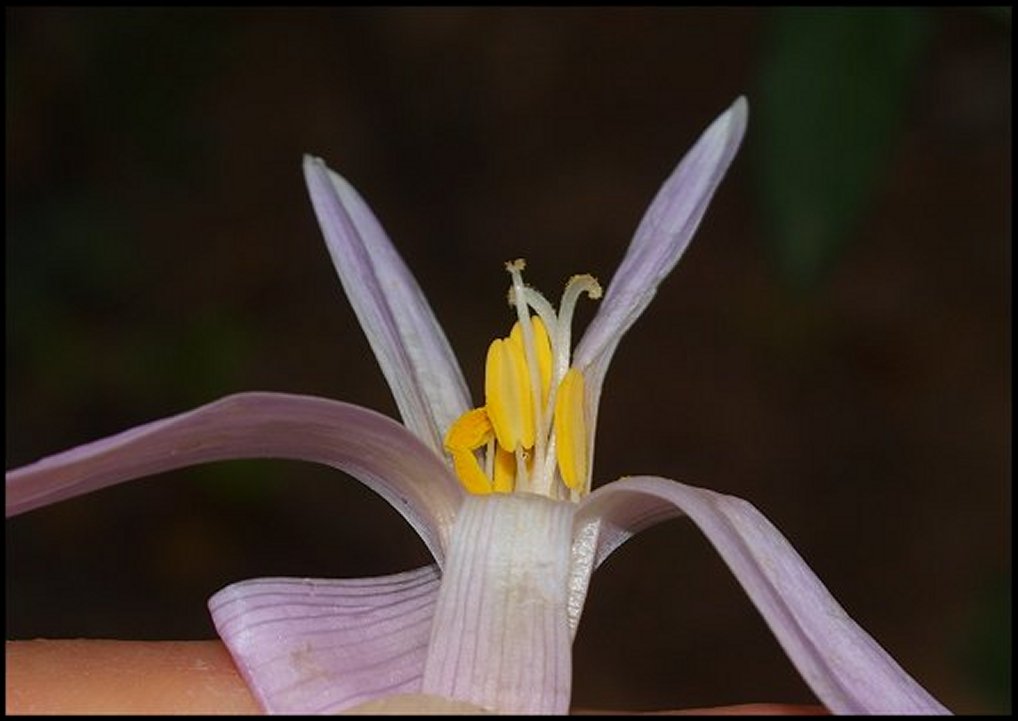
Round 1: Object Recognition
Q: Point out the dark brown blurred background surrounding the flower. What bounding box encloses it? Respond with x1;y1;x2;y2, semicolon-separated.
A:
5;8;1012;712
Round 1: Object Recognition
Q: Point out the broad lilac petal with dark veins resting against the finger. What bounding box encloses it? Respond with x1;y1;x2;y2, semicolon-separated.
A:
209;565;439;714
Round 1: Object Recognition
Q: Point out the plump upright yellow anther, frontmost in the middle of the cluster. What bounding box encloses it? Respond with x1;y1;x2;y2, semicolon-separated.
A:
485;338;534;452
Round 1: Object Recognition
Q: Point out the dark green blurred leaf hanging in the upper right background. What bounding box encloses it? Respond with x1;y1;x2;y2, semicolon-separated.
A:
753;8;929;289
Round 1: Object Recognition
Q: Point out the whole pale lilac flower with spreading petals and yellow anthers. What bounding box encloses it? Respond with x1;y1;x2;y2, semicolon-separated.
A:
7;98;947;713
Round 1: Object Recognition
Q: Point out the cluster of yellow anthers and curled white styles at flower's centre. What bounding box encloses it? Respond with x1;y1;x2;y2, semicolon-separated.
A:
445;260;601;501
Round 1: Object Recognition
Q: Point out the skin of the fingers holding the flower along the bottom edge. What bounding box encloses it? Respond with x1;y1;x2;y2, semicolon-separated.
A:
6;640;826;715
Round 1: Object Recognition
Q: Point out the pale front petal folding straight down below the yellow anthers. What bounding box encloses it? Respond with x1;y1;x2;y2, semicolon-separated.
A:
421;494;576;714
